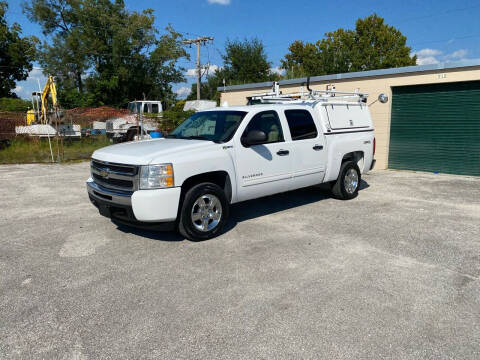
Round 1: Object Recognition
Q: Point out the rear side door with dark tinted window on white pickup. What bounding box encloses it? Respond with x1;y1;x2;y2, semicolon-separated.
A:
284;109;327;189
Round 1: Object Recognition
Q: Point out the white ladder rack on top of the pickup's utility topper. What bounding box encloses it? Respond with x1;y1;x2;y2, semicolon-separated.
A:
248;78;368;105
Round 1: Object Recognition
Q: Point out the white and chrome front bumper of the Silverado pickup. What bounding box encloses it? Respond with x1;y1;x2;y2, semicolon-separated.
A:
87;179;181;230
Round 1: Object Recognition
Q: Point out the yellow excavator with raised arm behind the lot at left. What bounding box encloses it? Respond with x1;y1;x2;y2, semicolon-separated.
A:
27;75;59;125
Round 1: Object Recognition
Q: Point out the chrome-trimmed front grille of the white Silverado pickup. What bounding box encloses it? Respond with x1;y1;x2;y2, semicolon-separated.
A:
90;159;139;193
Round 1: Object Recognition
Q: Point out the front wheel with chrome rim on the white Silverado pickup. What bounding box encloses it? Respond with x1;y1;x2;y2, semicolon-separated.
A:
178;183;229;241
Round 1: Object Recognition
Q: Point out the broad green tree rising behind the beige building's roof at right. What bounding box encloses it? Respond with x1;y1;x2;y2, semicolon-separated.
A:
282;14;417;77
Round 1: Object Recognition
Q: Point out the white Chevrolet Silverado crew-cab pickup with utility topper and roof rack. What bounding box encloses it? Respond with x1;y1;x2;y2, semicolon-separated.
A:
87;87;375;240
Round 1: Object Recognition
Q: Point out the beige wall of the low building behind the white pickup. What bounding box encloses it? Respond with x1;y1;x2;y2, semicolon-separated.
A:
221;67;480;169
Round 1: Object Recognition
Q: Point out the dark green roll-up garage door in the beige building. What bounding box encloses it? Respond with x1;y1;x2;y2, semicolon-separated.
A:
388;81;480;175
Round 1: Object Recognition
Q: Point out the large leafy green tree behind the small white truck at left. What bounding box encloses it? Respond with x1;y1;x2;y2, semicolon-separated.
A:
24;0;188;107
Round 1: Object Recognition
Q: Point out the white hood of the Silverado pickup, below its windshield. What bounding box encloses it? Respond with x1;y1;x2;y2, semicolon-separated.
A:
92;138;216;165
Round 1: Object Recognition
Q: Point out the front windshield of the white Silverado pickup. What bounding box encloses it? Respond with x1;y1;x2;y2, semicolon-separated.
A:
167;111;247;142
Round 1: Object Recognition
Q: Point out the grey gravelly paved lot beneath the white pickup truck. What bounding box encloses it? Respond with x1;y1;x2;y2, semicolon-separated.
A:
0;163;480;359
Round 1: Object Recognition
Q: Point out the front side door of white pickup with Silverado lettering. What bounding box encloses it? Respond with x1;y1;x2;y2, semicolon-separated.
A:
235;110;293;201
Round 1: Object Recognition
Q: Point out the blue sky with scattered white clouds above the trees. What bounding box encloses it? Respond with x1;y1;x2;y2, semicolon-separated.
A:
7;0;480;98
